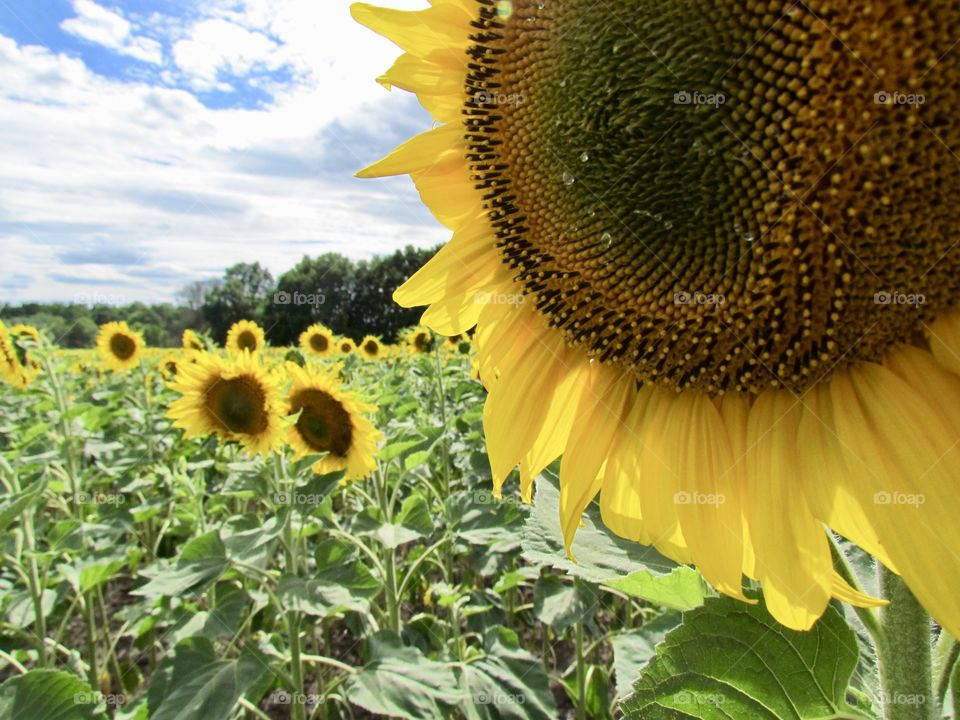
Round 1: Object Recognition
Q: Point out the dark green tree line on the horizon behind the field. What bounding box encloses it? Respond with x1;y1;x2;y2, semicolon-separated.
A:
0;246;436;348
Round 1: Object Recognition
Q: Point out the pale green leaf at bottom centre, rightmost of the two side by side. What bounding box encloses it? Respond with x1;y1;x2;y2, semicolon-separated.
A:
460;628;559;720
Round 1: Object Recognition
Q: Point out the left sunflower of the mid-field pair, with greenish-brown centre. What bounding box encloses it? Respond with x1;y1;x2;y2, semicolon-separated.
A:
167;350;283;455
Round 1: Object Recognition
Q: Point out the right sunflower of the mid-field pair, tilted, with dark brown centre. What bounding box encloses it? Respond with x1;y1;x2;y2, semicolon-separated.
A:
287;363;382;480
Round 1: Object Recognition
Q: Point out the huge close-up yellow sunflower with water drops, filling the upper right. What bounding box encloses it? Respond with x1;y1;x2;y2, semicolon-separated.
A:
352;0;960;636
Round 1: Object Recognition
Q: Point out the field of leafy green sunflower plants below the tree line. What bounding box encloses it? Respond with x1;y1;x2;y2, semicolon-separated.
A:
0;328;946;720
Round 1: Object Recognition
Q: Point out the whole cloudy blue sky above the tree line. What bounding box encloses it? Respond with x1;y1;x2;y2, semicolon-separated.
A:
0;0;448;304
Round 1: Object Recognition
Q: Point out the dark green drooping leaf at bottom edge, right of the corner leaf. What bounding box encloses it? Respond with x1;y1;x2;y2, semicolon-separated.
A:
147;637;268;720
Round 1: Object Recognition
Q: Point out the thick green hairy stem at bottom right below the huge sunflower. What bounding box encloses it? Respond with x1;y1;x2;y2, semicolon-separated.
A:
877;563;937;720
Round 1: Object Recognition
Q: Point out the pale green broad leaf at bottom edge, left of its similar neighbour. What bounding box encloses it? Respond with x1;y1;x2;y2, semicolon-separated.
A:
344;631;460;720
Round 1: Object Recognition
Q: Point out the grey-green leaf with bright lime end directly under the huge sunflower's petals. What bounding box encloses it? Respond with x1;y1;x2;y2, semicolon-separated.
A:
523;472;704;610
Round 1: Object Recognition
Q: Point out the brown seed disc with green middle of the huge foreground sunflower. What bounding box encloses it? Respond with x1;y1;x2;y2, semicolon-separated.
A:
464;0;960;394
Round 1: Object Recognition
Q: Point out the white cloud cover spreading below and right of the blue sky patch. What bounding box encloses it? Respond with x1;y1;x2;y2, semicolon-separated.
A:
0;0;447;301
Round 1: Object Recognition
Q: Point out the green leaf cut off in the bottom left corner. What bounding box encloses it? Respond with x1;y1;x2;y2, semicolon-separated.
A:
0;670;102;720
